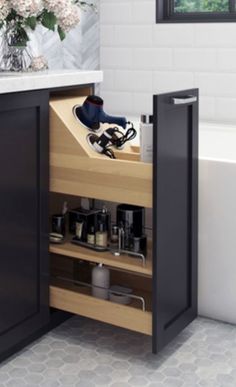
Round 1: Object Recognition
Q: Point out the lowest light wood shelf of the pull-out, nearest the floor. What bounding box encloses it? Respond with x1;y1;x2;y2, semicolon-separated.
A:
50;280;152;335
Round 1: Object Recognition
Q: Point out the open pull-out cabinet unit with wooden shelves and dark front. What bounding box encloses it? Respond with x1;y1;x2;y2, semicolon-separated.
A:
50;89;198;353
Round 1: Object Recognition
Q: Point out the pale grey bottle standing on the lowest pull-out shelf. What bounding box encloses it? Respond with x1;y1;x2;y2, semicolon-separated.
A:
92;263;110;300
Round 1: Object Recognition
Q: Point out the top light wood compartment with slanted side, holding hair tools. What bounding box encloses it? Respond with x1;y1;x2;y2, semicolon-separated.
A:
50;97;152;208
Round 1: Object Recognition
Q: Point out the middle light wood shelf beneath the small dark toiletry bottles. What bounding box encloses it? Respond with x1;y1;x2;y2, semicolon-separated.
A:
50;242;152;277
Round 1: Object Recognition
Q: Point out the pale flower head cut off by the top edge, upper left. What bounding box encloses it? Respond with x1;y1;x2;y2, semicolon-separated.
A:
8;0;43;18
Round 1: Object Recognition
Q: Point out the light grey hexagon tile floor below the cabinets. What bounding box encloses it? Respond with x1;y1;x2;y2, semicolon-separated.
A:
0;317;236;387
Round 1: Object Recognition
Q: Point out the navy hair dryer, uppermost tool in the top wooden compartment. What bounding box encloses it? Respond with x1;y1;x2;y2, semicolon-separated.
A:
73;95;127;131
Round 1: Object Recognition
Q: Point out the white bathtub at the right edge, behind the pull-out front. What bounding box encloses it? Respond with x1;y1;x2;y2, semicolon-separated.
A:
198;124;236;324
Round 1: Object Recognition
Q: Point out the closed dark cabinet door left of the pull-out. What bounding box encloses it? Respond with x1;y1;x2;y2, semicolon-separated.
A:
0;92;49;356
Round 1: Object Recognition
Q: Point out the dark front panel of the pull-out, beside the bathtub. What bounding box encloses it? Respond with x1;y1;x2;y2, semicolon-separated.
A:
153;90;198;352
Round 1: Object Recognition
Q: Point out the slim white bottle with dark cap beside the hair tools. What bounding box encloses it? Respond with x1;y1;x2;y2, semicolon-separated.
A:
140;114;153;163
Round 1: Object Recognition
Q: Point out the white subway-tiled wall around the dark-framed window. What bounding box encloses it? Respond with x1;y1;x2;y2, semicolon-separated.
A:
100;0;236;122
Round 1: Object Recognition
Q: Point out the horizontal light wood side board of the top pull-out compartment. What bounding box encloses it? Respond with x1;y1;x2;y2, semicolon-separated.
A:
50;154;152;208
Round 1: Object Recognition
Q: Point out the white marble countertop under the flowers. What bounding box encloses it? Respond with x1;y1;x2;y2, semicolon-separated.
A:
0;70;103;94
